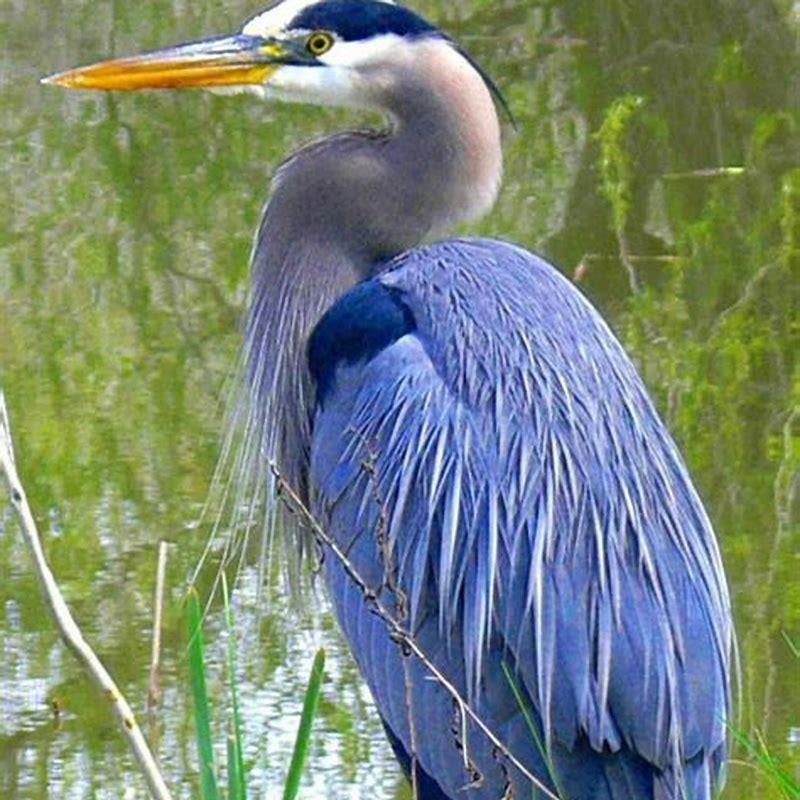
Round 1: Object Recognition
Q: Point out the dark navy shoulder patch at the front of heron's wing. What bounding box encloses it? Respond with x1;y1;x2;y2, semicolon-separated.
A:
308;280;417;405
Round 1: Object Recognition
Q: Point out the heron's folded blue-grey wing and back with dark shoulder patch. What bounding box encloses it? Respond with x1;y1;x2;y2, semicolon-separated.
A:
310;240;731;800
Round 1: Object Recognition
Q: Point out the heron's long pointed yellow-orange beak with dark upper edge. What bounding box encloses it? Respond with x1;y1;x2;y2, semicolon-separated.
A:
42;34;296;91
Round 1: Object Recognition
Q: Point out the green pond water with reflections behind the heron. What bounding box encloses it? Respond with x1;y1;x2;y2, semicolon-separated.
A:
0;0;800;800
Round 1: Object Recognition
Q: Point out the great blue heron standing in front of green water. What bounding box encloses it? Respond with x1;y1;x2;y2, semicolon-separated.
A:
43;0;732;800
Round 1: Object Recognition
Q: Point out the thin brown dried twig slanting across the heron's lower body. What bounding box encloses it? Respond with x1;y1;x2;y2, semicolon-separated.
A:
270;462;559;800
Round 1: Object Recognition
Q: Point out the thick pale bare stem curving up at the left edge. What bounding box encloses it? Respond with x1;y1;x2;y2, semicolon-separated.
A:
0;392;172;800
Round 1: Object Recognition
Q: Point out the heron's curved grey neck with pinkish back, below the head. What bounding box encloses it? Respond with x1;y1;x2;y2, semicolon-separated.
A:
246;42;501;491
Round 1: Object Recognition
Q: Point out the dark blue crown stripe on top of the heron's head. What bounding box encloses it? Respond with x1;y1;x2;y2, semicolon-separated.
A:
289;0;437;42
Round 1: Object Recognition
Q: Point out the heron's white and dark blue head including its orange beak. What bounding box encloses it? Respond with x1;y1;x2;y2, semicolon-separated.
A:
44;0;506;119
